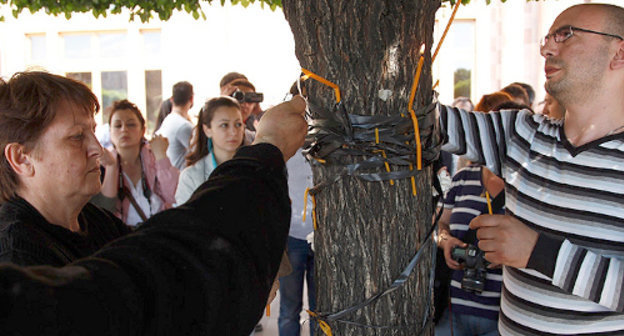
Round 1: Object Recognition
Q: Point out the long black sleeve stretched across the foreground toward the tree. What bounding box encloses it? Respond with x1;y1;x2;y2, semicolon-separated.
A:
0;144;290;335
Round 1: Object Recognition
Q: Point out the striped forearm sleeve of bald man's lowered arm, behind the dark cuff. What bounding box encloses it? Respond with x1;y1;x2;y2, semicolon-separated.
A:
552;240;624;312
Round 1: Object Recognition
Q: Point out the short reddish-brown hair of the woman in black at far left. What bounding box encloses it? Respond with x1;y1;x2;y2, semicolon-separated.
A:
0;71;100;202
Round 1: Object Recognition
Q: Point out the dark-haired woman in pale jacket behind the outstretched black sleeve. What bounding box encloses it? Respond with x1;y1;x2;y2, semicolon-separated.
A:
175;96;245;205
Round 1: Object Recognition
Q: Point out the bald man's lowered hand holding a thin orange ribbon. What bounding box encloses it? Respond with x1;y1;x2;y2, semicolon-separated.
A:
470;215;538;268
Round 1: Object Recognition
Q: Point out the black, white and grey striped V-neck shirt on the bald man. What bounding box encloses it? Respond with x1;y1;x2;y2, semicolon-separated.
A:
440;106;624;335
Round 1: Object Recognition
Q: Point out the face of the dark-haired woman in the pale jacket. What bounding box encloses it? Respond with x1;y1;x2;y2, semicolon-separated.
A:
202;106;245;152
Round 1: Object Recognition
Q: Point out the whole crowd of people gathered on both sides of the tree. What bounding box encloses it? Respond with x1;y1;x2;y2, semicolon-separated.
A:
0;4;624;336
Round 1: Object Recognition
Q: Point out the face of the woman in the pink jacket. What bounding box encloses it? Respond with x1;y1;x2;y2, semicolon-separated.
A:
110;109;145;149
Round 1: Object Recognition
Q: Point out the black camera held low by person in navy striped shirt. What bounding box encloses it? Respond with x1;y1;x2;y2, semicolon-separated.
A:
451;244;490;294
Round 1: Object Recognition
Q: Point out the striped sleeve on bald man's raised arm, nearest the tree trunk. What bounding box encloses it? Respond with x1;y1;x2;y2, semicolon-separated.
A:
440;105;518;176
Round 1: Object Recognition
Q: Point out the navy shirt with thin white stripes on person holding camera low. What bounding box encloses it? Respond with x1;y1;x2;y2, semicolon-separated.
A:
444;165;502;320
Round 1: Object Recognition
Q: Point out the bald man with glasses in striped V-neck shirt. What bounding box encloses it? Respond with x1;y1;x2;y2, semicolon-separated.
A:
440;4;624;335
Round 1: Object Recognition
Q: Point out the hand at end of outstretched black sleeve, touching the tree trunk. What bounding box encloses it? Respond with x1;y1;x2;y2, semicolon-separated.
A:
253;96;308;161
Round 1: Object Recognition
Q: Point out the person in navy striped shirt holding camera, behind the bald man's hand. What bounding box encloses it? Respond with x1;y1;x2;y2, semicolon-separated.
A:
436;164;504;336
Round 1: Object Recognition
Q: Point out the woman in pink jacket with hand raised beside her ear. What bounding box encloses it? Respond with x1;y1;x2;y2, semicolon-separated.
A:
94;99;180;225
